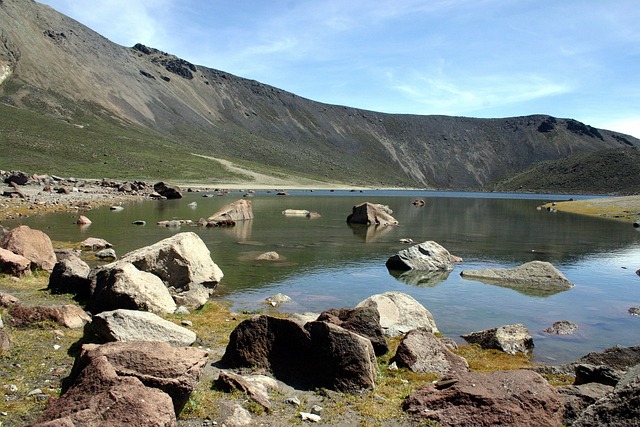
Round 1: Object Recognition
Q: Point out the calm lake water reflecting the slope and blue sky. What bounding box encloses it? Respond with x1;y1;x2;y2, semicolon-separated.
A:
4;191;640;363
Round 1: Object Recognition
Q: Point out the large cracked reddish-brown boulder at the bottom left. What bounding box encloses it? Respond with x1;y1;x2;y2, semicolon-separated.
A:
36;341;208;427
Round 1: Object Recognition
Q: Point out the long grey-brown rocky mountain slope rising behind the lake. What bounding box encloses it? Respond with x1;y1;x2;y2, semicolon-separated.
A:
0;0;640;189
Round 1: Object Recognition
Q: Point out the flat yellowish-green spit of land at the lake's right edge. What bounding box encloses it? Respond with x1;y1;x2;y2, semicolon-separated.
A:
542;195;640;222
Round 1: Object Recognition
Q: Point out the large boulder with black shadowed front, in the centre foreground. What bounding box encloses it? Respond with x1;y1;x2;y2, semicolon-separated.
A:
221;316;377;392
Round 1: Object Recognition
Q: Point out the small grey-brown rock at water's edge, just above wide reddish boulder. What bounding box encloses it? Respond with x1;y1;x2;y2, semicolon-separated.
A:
462;323;533;354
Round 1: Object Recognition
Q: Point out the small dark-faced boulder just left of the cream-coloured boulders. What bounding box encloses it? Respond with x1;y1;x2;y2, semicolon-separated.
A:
48;255;91;298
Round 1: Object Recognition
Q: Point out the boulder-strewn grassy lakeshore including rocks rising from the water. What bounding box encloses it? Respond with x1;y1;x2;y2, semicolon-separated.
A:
0;173;640;427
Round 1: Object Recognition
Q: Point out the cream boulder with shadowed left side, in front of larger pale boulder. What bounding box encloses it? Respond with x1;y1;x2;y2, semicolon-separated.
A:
89;260;176;313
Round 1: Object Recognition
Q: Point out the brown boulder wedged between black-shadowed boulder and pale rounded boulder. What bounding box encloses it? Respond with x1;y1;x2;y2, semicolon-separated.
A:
317;307;389;356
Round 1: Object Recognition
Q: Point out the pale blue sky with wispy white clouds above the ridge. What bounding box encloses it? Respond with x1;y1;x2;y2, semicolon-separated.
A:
38;0;640;138
